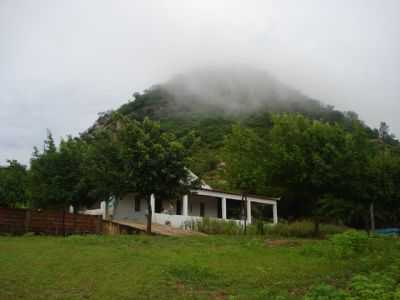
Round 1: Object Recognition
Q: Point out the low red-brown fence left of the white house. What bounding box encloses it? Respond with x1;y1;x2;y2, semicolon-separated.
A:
0;207;102;235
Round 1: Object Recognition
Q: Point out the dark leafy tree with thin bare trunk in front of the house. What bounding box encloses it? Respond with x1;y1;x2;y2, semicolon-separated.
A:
118;118;193;233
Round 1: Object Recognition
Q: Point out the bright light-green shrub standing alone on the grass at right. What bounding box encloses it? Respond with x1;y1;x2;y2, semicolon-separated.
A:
330;230;369;256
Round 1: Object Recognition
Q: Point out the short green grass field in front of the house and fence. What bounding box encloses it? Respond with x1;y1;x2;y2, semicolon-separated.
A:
0;236;398;300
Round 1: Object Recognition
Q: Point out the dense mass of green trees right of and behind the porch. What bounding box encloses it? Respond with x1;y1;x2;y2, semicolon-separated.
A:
224;114;400;227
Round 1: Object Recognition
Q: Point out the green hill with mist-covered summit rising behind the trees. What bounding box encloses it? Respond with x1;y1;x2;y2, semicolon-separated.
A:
97;66;376;188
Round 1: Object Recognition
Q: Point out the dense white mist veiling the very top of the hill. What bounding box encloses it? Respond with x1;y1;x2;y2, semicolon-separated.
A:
163;66;306;113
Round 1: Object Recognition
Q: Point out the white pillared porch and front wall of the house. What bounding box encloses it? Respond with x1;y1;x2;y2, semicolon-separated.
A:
113;189;279;228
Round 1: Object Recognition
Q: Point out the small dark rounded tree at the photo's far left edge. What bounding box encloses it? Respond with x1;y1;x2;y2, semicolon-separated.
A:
0;160;29;207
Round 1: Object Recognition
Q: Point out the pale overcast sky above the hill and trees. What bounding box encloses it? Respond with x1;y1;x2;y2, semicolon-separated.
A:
0;0;400;163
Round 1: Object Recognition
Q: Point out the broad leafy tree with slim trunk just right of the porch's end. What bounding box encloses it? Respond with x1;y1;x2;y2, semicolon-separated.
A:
266;114;347;234
